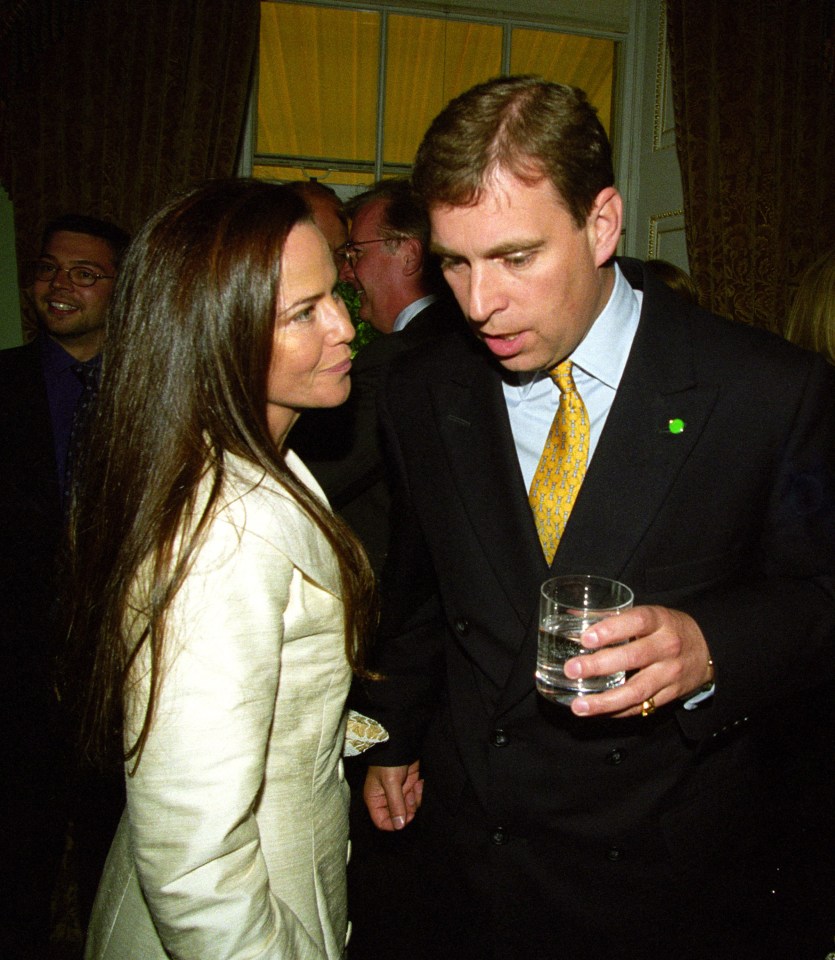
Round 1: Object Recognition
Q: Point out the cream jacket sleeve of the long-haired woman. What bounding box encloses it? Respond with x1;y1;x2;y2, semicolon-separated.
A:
127;515;323;960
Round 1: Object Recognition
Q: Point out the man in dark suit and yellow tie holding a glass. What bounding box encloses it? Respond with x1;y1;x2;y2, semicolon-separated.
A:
365;77;835;960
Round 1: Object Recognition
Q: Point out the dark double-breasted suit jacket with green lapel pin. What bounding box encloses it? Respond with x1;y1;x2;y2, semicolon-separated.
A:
370;261;835;960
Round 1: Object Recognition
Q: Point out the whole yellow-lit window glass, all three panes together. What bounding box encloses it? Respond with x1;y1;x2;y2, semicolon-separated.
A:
252;0;615;189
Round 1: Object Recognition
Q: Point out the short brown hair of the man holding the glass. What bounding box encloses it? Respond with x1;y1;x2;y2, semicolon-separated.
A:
412;76;615;226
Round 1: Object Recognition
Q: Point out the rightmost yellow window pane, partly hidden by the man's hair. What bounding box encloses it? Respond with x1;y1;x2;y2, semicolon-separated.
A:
510;28;615;133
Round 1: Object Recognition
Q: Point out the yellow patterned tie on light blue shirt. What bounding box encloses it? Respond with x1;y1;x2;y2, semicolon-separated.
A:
528;360;589;566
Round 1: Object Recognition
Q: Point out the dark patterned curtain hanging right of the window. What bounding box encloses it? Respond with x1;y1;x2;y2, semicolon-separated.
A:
667;0;835;331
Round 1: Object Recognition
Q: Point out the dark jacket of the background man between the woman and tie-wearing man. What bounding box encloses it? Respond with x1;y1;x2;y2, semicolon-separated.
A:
287;298;464;574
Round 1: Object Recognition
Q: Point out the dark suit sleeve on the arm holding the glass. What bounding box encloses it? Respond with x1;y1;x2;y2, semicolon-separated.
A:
680;361;835;736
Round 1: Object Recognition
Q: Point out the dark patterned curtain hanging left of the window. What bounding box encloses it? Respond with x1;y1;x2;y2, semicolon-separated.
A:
0;0;259;338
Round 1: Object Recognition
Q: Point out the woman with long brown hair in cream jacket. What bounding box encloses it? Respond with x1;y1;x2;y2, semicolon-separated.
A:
69;180;374;960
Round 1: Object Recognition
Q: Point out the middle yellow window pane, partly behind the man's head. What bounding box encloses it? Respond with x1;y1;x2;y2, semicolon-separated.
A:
383;14;502;164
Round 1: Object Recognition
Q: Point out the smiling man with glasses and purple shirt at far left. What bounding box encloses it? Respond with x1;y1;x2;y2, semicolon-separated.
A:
0;214;127;957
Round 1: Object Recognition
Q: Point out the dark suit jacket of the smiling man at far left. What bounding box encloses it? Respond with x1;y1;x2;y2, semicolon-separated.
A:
0;342;66;937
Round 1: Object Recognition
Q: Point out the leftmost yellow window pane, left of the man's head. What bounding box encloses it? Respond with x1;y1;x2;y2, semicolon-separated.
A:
255;3;380;162
